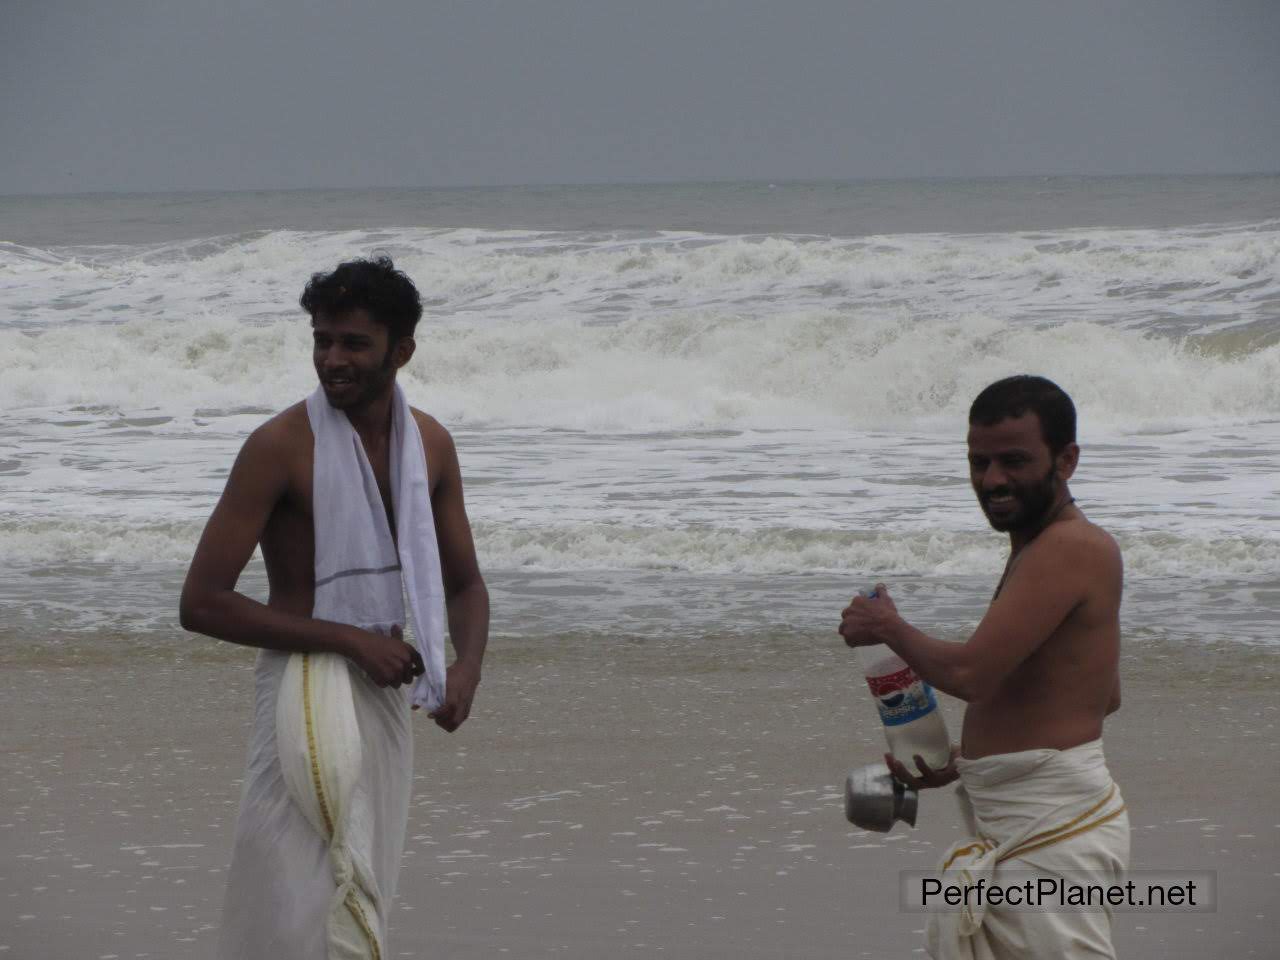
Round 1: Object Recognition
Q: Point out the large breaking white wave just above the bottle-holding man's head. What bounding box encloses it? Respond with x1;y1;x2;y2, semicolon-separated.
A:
0;310;1280;431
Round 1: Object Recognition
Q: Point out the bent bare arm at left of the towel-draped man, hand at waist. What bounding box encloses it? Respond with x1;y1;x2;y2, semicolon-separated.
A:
178;419;422;686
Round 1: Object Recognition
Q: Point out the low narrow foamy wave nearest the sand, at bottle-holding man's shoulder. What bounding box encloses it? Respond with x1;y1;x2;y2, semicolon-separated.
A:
0;518;1280;580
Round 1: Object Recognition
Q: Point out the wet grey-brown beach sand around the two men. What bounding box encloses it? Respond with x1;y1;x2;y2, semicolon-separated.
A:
0;632;1280;960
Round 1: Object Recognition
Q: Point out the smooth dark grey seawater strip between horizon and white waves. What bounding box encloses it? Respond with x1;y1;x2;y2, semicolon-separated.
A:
0;174;1280;246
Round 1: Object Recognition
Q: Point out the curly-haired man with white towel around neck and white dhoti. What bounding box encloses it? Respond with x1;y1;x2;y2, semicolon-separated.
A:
180;257;489;960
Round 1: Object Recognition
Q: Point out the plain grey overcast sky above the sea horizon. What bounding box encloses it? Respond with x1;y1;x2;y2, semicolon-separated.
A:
0;0;1280;193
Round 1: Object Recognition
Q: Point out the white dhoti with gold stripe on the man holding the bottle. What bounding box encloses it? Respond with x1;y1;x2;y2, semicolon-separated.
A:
927;740;1129;960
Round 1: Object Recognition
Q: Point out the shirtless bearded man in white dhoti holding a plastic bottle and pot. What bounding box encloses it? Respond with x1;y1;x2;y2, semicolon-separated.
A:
840;375;1129;960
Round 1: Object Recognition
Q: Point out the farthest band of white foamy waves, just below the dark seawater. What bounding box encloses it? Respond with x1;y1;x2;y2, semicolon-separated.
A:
0;221;1280;330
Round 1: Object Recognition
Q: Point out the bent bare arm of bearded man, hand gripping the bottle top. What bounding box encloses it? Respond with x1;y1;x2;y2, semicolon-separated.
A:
840;527;1098;703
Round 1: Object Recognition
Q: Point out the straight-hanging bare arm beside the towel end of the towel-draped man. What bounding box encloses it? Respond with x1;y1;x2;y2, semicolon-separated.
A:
420;420;489;733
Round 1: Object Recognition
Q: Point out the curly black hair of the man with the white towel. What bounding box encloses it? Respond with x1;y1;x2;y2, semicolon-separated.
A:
298;256;422;343
